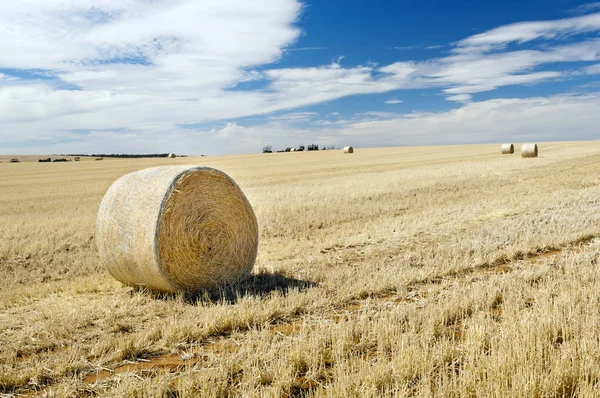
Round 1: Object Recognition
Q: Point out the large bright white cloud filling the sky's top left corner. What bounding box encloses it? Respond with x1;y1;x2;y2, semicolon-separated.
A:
0;0;300;70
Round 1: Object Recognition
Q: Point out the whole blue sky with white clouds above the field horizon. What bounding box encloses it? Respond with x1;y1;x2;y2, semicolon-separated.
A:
0;0;600;155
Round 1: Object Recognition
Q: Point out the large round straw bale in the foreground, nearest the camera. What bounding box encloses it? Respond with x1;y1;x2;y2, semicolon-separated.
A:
96;166;258;292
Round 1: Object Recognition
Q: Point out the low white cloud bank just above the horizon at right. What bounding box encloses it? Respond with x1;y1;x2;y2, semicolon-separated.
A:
332;95;600;146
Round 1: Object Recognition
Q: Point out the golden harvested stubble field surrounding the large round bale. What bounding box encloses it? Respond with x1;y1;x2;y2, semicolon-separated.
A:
0;141;600;397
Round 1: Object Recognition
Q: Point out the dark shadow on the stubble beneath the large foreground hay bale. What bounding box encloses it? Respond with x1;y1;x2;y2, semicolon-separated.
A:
134;272;318;305
